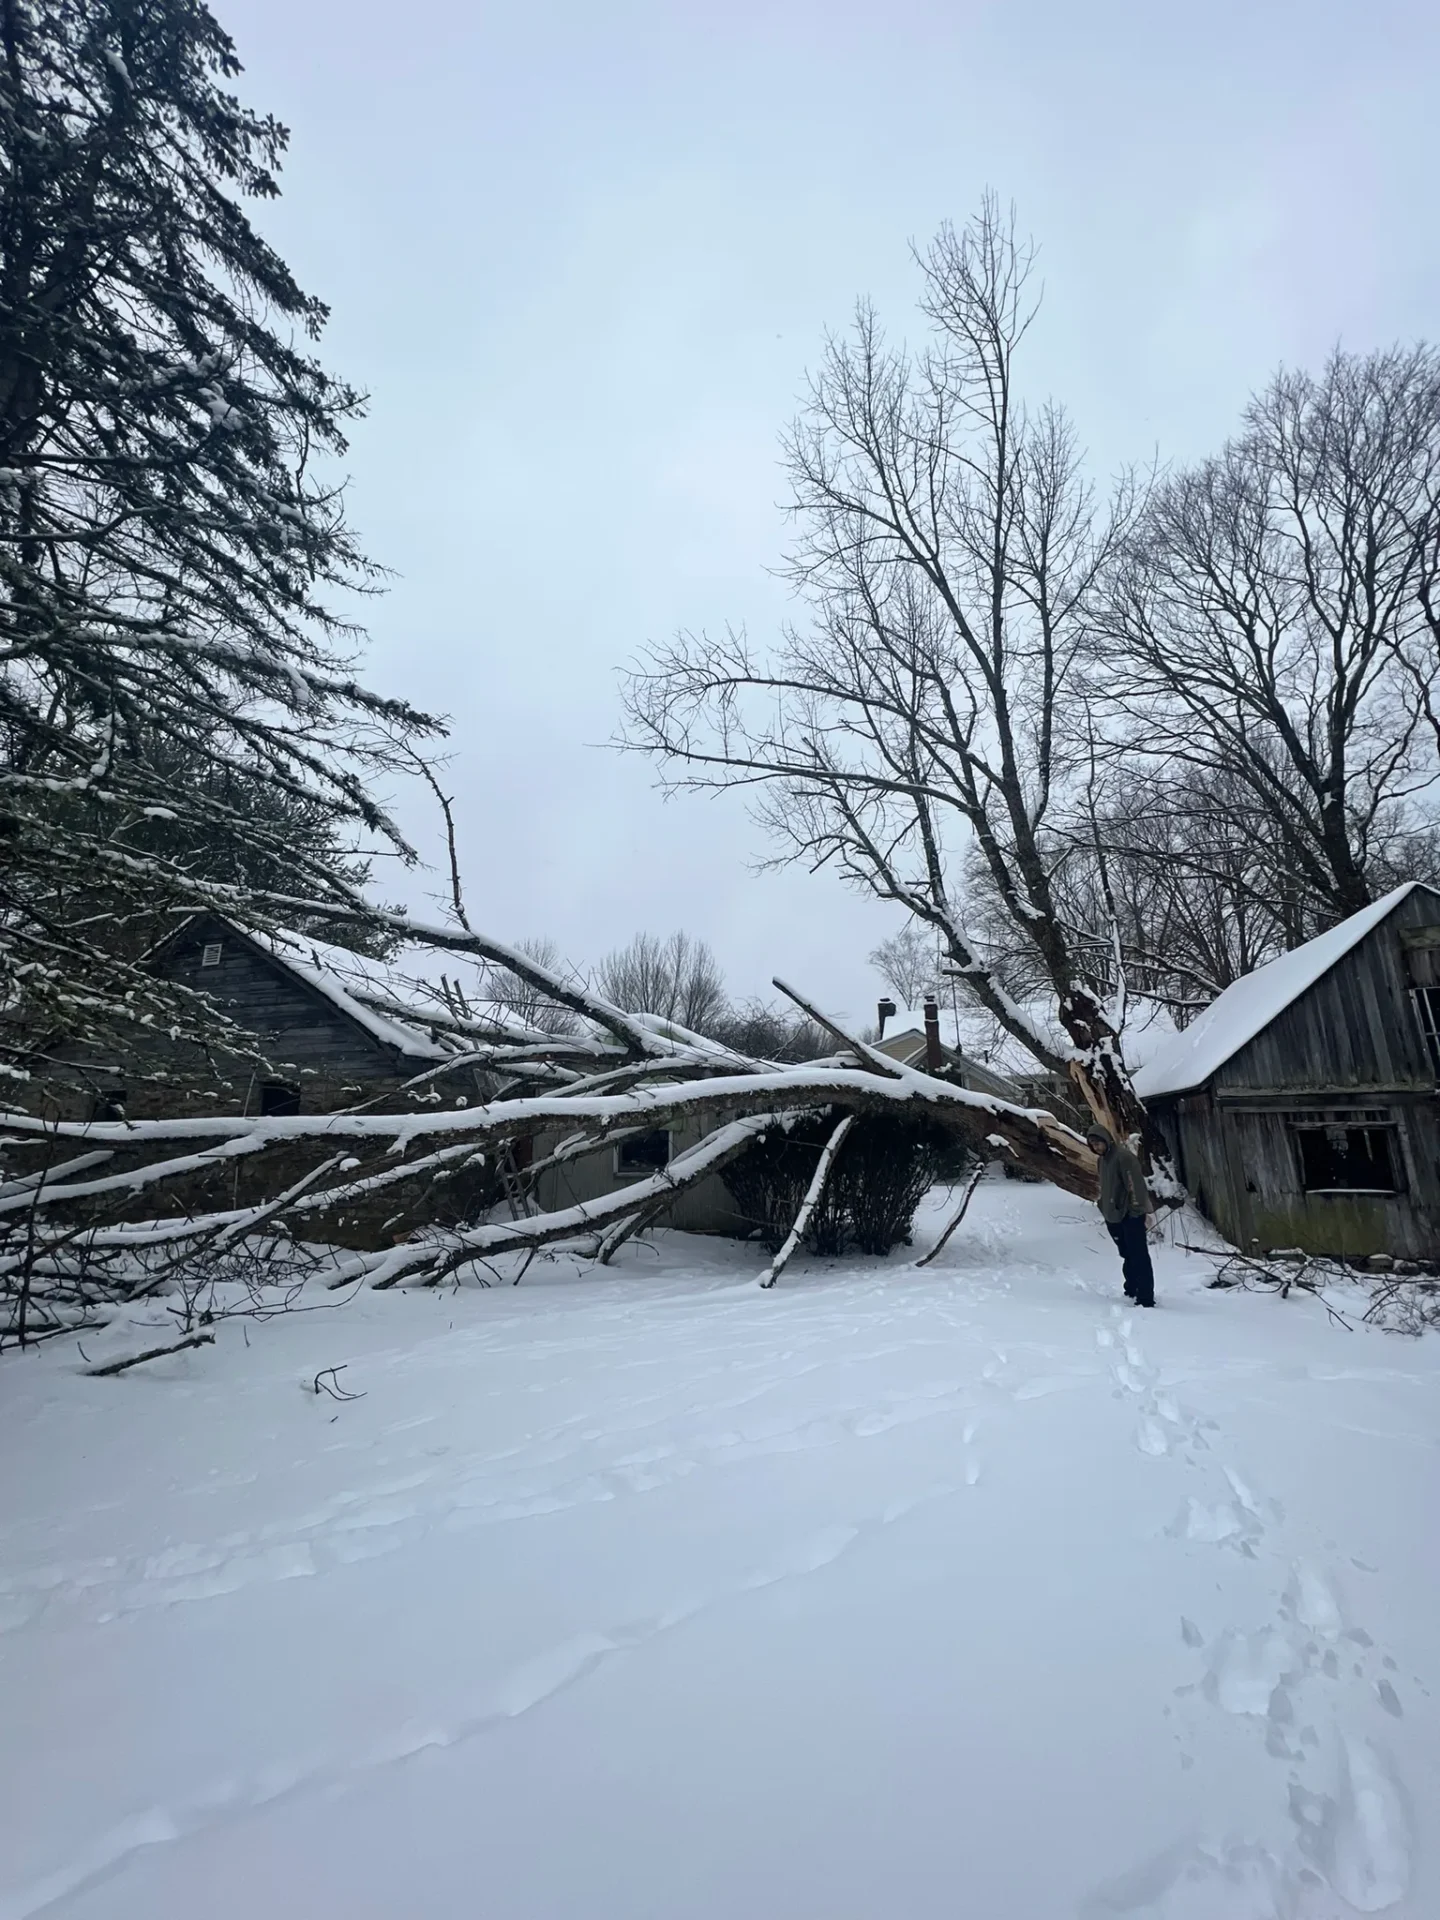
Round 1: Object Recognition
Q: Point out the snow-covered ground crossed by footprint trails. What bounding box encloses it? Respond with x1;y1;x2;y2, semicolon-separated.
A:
0;1183;1440;1920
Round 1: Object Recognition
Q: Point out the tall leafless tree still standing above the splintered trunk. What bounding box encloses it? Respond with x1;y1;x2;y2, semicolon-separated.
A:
628;198;1160;1152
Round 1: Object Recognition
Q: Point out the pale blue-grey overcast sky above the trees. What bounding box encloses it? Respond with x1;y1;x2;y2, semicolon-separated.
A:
213;0;1440;1018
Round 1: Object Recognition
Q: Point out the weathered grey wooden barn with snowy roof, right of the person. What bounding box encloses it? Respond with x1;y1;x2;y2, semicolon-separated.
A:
1135;881;1440;1260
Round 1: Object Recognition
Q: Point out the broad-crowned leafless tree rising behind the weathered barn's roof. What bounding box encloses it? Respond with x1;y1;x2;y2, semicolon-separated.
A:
1094;348;1440;945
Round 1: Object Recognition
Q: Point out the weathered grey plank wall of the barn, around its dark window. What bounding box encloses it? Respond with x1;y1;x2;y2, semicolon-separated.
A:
1160;887;1440;1260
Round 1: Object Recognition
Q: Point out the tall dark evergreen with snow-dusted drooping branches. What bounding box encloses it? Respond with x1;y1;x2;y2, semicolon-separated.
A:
0;0;436;1066
